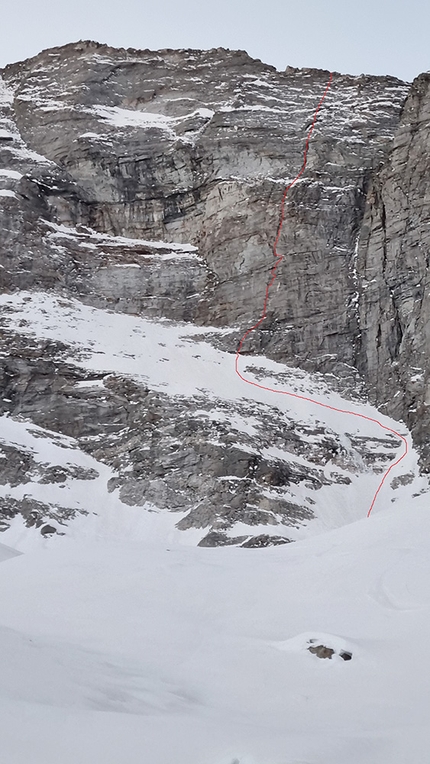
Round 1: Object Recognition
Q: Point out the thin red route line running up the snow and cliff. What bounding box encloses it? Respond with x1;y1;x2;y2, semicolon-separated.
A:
235;73;409;517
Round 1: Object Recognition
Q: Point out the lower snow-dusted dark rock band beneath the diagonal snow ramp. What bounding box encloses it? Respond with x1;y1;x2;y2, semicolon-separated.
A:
0;300;388;546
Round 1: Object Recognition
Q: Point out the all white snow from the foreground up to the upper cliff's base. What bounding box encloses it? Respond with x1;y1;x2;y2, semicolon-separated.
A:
0;293;430;764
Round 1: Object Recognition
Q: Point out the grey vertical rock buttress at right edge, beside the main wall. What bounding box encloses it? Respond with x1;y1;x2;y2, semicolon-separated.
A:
357;74;430;470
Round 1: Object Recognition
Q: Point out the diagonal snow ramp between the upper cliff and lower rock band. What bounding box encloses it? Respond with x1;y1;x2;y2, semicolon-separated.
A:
0;292;427;539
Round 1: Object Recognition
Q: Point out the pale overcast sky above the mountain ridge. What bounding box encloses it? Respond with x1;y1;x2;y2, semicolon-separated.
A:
0;0;430;80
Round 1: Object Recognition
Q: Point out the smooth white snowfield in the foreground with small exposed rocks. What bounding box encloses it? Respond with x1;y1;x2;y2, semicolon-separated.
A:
0;496;430;764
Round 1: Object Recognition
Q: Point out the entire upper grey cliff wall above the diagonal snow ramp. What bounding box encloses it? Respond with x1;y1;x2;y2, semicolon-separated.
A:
0;42;430;472
